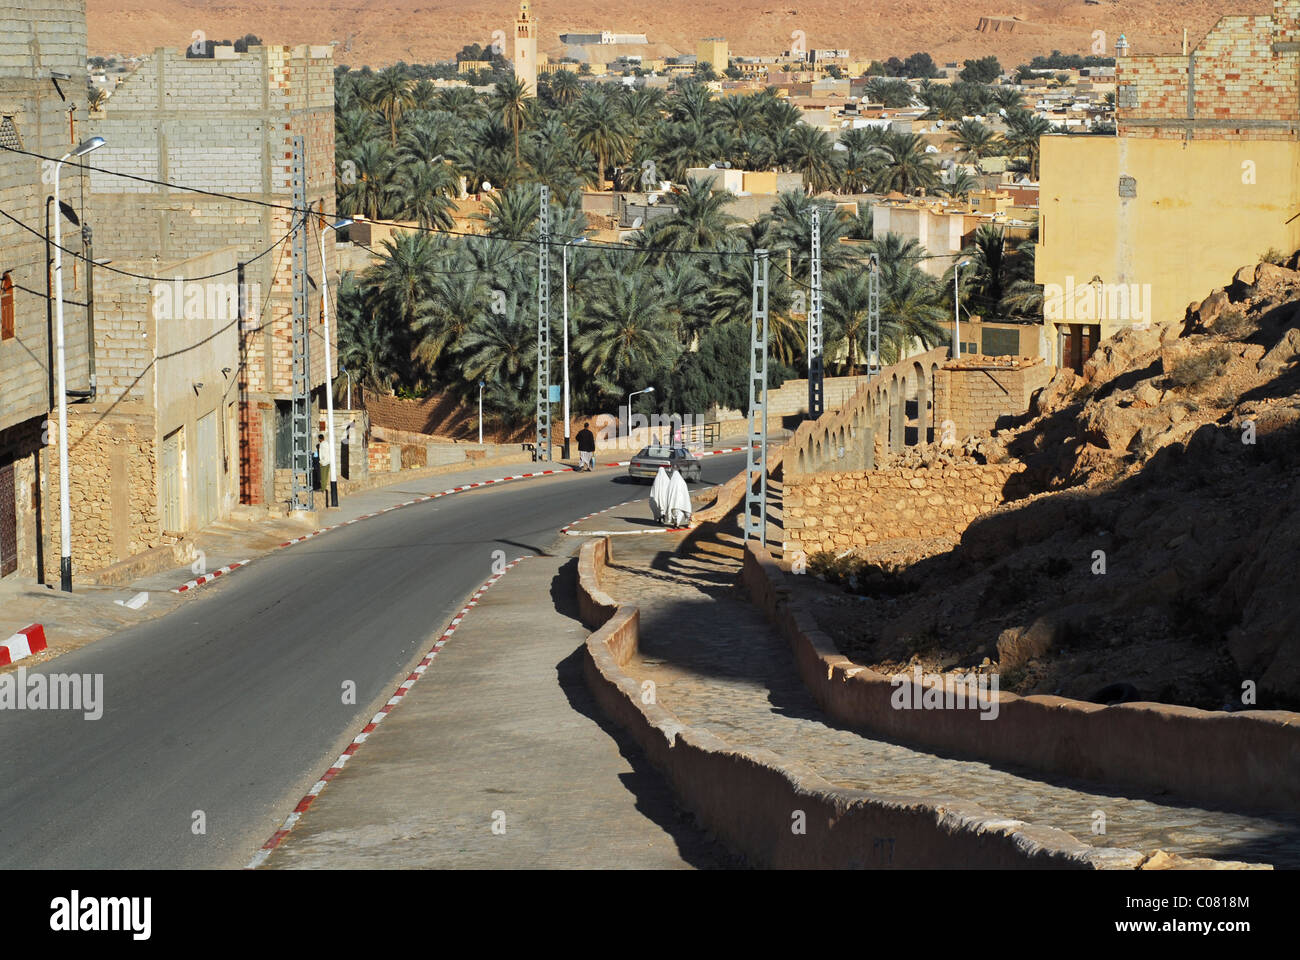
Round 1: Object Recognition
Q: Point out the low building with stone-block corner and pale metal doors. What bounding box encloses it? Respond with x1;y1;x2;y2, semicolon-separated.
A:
47;246;239;576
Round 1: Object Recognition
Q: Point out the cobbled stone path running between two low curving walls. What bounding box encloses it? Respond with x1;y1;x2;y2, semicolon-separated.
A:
603;535;1300;868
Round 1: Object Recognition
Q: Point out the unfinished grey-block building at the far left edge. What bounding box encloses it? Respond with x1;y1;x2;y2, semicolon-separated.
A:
0;0;90;581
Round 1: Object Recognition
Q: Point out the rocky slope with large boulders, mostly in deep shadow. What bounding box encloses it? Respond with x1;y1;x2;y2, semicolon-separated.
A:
810;258;1300;709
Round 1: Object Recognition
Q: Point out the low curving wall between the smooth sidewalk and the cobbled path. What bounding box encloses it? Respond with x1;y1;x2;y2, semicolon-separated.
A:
577;537;1164;869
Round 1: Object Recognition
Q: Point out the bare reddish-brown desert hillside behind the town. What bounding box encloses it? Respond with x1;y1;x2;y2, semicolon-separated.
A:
86;0;1270;68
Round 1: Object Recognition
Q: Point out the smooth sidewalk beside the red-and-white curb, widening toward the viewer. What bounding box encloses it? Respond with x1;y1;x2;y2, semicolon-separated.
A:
264;546;728;869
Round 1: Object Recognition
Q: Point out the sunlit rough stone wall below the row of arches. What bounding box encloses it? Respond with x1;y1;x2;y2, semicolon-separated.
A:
783;463;1024;554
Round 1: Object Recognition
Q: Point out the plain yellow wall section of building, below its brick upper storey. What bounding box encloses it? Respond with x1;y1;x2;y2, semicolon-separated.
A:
1035;137;1300;367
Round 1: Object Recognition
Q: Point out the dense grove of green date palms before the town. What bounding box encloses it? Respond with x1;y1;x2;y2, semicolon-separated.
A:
335;65;1048;425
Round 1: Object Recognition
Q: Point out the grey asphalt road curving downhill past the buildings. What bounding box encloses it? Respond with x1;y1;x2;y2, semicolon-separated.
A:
0;454;742;868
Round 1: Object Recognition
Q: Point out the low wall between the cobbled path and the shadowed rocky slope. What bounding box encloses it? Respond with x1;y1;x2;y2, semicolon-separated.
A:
742;544;1300;812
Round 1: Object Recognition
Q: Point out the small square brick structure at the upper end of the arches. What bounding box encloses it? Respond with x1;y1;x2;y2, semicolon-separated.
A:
935;356;1052;442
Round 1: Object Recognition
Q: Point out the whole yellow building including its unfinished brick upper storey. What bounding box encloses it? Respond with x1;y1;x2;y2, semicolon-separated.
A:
1035;0;1300;367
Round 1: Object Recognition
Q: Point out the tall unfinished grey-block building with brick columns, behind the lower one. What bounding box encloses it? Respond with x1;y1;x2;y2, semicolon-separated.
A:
87;46;338;503
